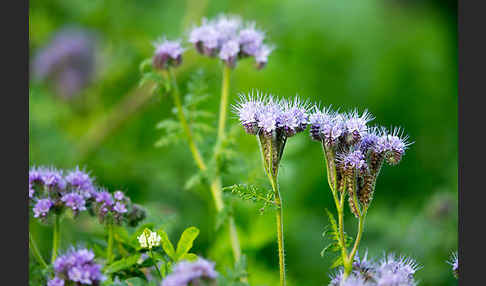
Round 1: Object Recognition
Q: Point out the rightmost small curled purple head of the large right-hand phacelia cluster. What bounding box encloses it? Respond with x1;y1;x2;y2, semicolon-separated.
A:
374;128;412;165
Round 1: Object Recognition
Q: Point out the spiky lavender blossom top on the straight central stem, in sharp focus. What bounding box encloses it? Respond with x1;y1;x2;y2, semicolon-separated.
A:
233;92;309;137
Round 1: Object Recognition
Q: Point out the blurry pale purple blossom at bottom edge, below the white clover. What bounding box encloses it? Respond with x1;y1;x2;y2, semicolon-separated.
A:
161;258;218;286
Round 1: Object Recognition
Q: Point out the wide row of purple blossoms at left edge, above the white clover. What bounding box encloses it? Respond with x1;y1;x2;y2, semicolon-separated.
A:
28;167;145;226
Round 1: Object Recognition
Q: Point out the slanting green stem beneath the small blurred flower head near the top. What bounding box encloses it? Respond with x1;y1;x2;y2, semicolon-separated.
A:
168;68;207;171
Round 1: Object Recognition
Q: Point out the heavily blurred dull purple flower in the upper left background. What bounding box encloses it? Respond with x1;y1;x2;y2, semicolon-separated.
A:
32;28;96;98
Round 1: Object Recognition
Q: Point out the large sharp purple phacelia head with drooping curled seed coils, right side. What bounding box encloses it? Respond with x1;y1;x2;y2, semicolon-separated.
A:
309;106;411;217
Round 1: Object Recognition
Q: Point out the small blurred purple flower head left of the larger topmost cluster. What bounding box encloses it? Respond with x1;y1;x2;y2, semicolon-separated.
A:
152;39;184;70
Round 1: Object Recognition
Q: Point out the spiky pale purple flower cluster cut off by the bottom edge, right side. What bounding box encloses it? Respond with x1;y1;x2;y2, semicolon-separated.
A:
329;254;420;286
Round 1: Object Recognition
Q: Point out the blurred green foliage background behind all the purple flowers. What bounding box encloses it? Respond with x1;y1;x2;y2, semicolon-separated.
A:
29;0;458;285
